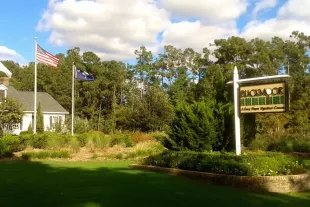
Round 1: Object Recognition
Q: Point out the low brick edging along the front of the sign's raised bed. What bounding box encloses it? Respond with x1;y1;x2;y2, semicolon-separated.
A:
129;164;310;193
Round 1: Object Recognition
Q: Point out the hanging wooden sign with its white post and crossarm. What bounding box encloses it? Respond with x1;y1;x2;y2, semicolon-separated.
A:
227;66;290;155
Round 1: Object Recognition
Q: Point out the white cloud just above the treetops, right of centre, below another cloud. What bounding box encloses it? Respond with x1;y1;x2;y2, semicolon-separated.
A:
162;21;238;52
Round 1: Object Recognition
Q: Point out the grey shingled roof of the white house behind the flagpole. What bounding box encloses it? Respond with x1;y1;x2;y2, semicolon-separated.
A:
8;86;68;114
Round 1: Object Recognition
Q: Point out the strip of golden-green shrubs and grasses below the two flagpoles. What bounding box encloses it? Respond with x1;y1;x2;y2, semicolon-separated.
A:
0;131;165;158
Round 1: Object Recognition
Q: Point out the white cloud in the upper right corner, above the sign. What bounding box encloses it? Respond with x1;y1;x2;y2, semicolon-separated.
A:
240;0;310;40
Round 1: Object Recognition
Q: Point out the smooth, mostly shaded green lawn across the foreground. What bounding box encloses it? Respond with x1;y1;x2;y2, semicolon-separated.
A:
0;161;310;207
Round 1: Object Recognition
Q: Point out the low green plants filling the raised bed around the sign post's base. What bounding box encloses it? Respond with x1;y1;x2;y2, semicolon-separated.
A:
142;151;305;176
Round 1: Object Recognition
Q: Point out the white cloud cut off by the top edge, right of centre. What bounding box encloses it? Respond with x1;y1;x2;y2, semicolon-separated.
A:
158;0;248;23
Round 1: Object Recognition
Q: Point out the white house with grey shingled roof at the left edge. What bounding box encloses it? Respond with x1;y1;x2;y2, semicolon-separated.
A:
0;62;69;134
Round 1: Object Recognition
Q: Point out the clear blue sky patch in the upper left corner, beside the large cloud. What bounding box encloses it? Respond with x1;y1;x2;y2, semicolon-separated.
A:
0;0;66;61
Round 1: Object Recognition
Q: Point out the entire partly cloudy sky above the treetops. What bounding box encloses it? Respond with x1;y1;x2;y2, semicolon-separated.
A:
0;0;310;64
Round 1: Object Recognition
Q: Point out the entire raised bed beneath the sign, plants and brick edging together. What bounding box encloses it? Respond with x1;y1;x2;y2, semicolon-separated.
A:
130;151;310;192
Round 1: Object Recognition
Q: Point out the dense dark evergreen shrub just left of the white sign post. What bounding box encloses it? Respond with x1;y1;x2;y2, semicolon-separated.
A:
167;101;217;151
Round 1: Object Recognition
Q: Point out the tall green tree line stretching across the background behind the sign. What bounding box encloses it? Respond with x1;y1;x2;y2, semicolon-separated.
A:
3;31;310;149
